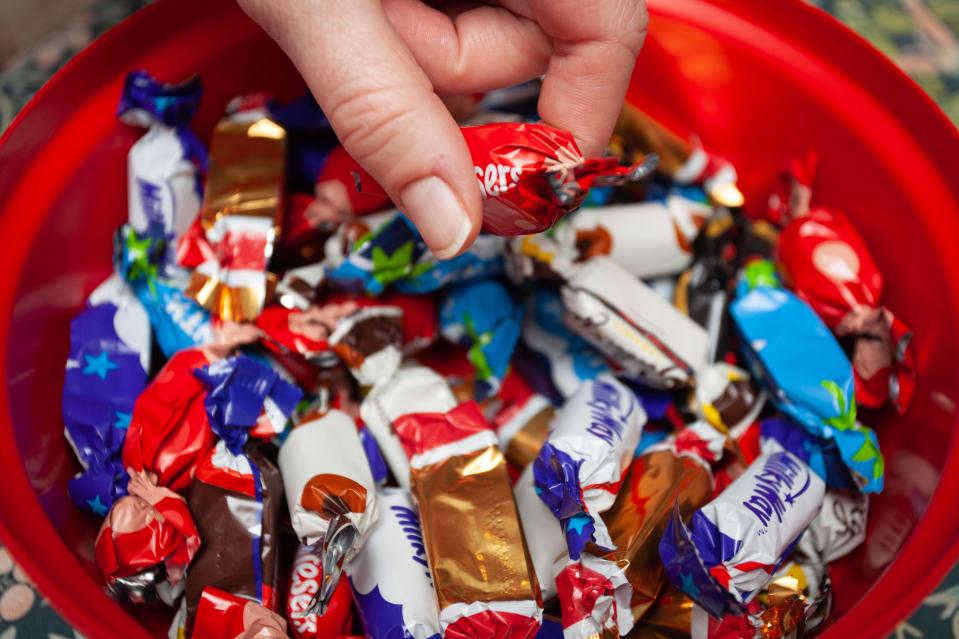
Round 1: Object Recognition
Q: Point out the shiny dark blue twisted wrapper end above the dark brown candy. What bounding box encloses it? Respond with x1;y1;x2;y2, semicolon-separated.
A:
193;355;303;455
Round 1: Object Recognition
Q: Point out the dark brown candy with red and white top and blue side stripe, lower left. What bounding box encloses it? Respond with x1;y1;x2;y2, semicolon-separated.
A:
186;442;283;638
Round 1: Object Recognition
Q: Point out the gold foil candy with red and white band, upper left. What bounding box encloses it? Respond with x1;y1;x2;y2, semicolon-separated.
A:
186;111;286;322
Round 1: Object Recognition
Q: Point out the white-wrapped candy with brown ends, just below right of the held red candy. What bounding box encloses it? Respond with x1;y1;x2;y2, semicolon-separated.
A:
568;189;712;278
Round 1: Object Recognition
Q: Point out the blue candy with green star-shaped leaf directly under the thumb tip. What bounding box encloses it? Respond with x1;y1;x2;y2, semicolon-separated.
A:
329;214;504;295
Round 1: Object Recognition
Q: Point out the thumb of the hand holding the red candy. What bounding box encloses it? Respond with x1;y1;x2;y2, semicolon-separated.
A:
240;0;482;258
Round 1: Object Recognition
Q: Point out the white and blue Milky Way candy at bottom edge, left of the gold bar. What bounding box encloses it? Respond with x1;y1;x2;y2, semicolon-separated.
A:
346;488;440;639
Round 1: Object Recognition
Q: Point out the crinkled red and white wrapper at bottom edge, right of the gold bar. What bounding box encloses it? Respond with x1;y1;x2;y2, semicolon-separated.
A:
556;554;633;639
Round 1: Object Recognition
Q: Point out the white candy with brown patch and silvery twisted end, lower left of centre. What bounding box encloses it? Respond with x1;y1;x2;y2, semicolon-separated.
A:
279;410;378;613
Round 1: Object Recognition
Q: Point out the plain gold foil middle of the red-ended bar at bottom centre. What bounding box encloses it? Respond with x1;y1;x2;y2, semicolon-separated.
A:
411;446;539;610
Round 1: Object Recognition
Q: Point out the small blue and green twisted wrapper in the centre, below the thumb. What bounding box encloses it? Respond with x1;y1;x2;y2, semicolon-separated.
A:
440;280;523;401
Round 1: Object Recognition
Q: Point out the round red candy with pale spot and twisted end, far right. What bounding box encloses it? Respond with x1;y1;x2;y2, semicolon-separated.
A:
777;207;916;415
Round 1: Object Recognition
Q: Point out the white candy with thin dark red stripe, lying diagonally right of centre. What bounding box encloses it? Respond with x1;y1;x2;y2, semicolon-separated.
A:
562;256;709;389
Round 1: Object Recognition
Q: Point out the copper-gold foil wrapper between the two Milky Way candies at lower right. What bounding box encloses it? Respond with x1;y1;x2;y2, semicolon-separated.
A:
592;450;713;621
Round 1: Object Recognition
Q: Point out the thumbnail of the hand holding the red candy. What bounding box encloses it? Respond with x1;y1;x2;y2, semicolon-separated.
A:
400;175;473;260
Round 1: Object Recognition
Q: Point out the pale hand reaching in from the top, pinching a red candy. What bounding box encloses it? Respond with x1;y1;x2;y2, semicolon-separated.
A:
239;0;647;258
